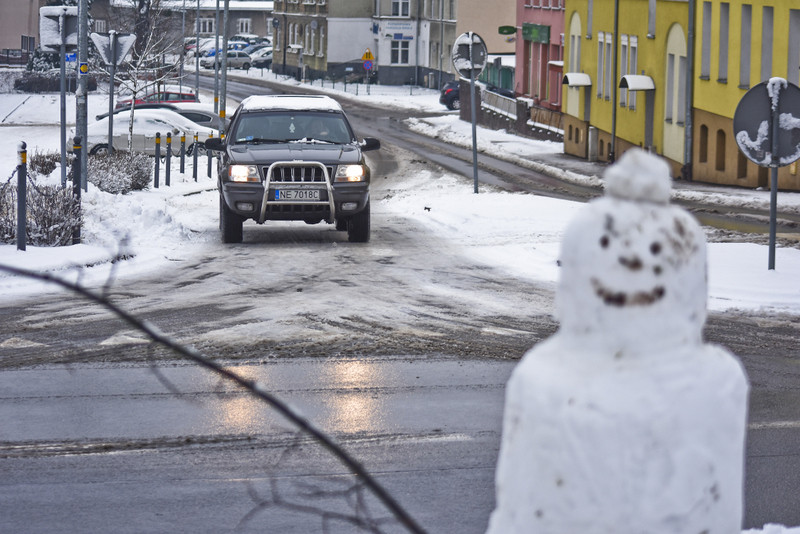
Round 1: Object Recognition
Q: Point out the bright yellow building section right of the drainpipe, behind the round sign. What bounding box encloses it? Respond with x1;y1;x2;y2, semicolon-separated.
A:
692;0;800;190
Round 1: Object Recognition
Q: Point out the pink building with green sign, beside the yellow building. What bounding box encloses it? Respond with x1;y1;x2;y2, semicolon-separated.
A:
514;0;566;111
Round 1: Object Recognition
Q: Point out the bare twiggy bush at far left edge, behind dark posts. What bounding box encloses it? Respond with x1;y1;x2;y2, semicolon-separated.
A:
0;177;82;247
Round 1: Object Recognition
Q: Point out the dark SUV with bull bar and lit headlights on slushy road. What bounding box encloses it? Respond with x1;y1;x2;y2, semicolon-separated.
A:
205;95;380;243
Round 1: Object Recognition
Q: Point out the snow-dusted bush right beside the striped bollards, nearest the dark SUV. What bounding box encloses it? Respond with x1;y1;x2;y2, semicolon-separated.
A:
87;151;153;195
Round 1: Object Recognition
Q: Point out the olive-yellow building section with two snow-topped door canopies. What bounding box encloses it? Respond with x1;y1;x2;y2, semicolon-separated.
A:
563;0;689;175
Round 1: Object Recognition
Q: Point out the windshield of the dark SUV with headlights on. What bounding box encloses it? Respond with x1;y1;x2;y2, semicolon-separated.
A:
231;111;354;145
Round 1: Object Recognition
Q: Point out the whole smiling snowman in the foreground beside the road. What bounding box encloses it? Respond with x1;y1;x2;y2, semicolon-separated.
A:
488;149;749;534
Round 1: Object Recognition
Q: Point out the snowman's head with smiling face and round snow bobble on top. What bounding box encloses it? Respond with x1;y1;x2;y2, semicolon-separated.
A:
556;149;707;353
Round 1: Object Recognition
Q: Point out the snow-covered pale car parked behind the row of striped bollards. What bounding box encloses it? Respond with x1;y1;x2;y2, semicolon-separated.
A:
68;108;218;156
